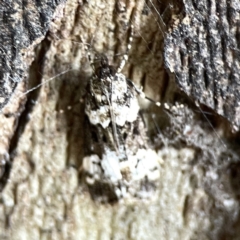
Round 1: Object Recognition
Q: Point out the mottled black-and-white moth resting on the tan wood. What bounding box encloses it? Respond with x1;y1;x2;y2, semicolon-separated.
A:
82;42;159;202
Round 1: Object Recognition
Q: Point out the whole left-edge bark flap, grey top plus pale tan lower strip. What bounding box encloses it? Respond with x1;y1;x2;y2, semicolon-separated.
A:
0;1;64;189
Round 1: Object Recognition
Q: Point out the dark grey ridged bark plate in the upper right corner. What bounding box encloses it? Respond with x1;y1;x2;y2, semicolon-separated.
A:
165;0;240;130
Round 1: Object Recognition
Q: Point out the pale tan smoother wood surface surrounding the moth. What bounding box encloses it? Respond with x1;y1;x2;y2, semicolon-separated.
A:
0;0;240;240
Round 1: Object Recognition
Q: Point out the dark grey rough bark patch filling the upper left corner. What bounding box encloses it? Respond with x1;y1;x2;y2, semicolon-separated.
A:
0;0;66;109
